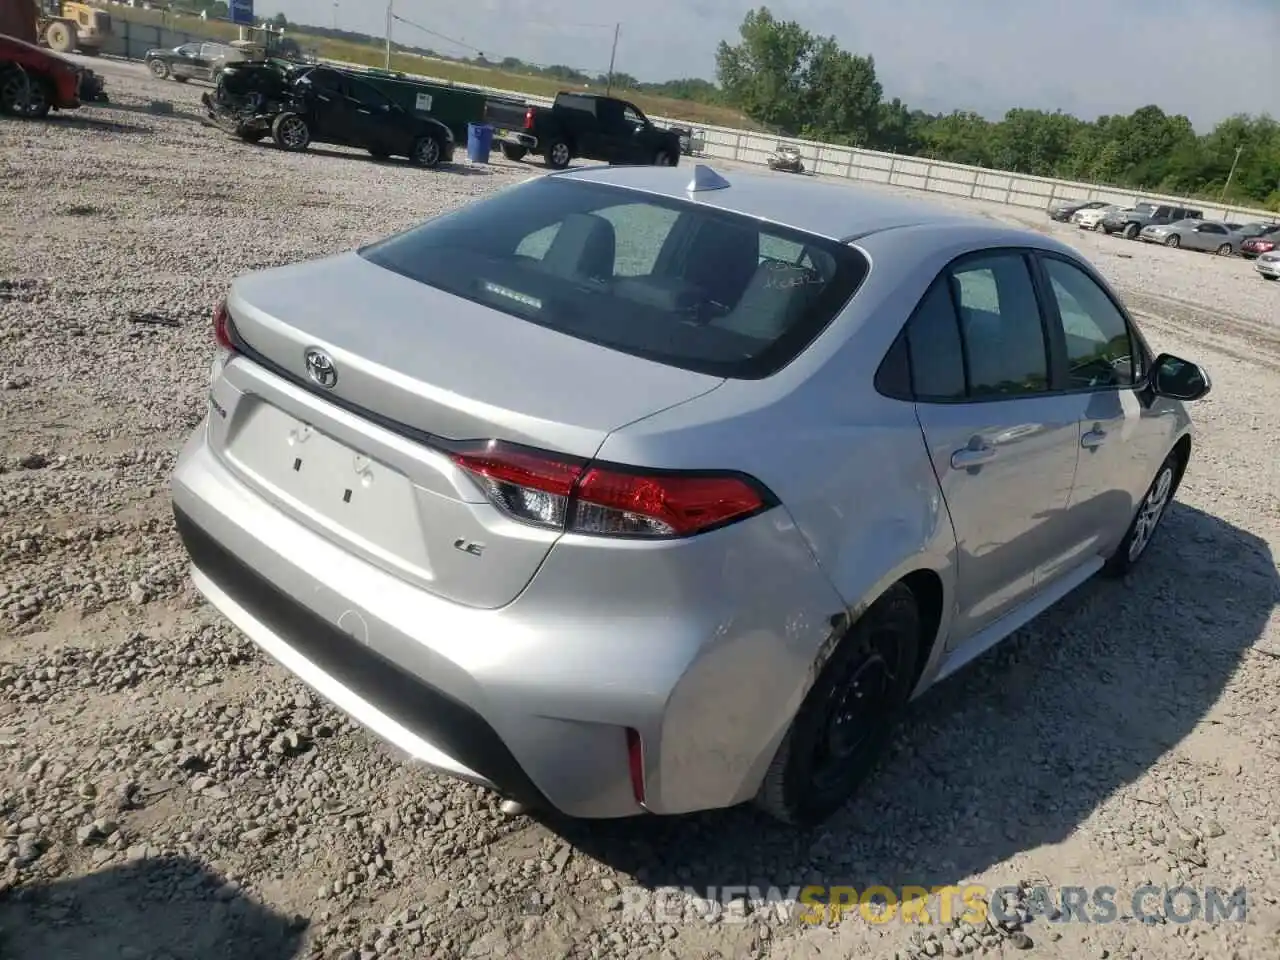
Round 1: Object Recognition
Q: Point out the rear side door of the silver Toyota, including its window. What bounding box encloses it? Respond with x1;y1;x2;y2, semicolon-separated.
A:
908;248;1080;644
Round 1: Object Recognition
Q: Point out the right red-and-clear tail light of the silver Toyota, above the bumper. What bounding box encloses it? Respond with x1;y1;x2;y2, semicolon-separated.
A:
449;440;777;539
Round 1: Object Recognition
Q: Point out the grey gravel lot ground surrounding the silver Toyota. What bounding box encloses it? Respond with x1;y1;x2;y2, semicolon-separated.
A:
0;63;1280;960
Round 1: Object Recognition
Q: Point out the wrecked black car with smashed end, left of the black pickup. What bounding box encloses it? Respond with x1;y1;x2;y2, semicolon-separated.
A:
201;60;454;168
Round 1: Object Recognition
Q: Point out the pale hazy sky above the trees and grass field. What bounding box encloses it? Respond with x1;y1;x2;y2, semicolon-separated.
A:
255;0;1280;131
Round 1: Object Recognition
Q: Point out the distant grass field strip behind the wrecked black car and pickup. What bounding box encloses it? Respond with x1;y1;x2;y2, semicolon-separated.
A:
110;6;760;131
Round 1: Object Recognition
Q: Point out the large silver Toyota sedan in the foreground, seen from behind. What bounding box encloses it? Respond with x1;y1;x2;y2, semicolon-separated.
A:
172;166;1210;823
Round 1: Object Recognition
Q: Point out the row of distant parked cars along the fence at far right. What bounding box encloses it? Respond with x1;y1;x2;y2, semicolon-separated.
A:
1046;200;1280;280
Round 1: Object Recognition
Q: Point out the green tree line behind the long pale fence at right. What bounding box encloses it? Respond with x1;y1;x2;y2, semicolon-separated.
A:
711;6;1280;210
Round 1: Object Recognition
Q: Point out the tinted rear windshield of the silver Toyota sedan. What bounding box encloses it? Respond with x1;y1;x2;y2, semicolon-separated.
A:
360;177;868;379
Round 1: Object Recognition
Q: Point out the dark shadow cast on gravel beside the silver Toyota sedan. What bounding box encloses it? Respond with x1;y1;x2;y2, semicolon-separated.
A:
555;504;1280;895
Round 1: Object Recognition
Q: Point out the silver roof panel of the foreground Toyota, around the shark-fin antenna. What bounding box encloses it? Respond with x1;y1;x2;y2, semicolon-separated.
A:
552;164;988;241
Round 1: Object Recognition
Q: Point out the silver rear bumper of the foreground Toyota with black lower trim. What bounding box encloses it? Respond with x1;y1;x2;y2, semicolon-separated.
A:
172;425;844;818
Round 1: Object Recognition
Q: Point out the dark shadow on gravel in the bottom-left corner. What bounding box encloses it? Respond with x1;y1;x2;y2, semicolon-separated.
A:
0;858;305;960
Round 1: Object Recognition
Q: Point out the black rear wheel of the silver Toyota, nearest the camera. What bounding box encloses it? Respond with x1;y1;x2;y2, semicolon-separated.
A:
755;584;920;826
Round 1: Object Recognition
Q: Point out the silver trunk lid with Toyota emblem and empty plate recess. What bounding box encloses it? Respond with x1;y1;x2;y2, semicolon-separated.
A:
210;253;723;608
